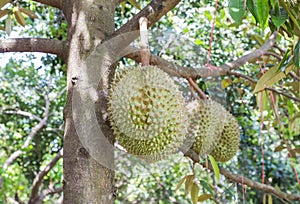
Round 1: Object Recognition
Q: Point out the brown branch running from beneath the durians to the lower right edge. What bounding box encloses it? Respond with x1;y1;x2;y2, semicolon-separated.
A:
184;150;300;201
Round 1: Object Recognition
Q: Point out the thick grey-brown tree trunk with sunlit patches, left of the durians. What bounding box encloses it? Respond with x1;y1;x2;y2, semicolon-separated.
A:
63;0;115;204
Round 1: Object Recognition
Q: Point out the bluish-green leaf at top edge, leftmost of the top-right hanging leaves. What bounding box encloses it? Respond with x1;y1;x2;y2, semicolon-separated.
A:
229;0;245;24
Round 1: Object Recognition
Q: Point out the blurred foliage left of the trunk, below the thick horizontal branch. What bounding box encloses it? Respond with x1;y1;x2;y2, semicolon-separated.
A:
0;55;65;201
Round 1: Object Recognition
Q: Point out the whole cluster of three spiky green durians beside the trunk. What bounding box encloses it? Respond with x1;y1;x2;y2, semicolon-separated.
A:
108;66;240;161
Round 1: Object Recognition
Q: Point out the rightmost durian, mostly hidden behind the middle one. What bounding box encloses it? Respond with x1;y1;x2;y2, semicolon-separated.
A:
211;112;240;162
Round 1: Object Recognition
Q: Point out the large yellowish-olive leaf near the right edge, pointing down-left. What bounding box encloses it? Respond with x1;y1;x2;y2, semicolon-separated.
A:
253;64;294;93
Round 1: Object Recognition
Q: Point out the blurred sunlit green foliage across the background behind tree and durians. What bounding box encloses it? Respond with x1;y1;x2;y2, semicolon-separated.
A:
0;0;300;203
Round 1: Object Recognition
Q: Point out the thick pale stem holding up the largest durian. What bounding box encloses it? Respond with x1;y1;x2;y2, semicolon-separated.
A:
139;17;150;66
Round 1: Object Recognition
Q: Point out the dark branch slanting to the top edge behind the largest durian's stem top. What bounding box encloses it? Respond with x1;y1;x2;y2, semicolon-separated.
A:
113;0;180;36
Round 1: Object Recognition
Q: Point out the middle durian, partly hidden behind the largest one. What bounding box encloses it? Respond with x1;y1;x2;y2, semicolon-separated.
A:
184;100;227;157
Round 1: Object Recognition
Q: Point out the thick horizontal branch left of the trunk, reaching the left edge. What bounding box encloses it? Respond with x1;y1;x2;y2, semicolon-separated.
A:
0;38;67;59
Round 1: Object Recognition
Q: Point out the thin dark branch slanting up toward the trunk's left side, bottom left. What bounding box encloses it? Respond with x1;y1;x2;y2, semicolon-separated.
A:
29;149;63;204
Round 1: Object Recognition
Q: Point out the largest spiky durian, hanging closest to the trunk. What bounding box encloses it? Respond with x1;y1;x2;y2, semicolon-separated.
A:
108;66;188;161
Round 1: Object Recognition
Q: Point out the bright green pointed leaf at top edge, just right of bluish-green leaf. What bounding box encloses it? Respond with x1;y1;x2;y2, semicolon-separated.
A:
254;0;270;30
